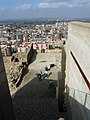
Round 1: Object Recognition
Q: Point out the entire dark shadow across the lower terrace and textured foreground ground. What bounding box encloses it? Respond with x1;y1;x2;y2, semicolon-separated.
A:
13;77;66;120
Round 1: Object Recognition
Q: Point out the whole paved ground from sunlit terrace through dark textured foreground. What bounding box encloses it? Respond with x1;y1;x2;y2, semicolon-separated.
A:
13;50;66;120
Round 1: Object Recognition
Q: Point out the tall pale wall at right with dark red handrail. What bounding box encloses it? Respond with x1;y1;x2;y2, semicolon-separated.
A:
66;22;90;120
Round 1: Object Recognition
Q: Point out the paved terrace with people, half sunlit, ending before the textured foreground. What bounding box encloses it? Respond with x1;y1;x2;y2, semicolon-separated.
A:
13;52;61;98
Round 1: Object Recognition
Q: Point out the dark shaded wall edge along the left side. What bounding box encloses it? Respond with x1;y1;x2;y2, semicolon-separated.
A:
0;49;15;120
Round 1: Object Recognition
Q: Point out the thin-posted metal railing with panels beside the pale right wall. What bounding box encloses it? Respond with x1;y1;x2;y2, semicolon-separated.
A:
66;87;90;120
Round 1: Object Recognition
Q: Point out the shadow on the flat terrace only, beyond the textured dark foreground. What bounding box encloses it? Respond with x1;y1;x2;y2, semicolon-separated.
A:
15;77;57;98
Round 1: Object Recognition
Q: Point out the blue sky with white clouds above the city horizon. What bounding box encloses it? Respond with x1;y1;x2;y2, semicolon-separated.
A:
0;0;90;20
